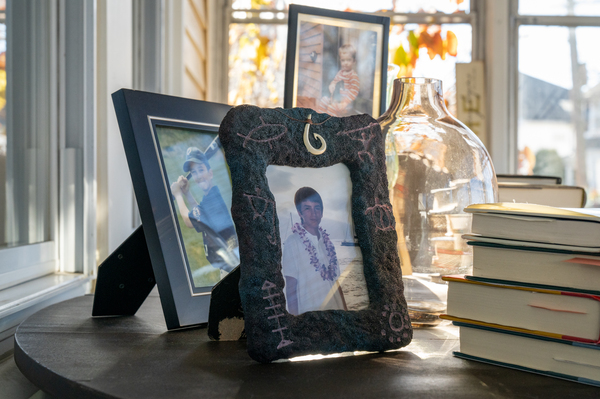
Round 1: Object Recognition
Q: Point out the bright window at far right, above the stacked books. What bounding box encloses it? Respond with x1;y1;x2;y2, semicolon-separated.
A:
512;0;600;206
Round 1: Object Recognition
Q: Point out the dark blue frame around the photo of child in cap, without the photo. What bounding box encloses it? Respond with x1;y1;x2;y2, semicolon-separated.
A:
112;89;237;330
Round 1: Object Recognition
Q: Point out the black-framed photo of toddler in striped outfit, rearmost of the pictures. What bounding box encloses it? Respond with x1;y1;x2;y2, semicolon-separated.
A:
284;4;390;118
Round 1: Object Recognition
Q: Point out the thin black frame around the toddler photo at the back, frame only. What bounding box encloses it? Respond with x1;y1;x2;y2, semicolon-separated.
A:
283;4;390;118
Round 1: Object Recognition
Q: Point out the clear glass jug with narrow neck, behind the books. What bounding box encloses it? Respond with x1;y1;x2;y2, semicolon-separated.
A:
378;78;498;326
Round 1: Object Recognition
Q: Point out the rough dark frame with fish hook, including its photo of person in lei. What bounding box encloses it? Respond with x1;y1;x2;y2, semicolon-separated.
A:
220;105;412;362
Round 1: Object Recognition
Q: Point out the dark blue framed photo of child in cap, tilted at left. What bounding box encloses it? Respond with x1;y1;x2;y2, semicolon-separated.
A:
112;89;239;330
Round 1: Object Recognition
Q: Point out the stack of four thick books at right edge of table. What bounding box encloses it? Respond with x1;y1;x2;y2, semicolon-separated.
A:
442;203;600;386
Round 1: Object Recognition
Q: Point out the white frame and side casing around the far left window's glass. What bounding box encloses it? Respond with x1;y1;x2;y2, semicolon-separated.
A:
0;0;96;296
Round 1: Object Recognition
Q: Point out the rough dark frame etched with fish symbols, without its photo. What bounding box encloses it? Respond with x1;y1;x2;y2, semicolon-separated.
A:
219;105;412;362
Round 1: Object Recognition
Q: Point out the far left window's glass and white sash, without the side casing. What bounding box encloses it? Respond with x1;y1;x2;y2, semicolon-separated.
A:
0;1;58;289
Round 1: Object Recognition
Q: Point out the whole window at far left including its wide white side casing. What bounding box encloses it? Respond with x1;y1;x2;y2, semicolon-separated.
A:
0;0;95;296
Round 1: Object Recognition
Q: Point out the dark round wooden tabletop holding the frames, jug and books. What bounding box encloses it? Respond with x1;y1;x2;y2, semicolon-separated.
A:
15;296;600;399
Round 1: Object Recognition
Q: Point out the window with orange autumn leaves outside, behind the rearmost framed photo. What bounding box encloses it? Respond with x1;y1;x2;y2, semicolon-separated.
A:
228;0;479;118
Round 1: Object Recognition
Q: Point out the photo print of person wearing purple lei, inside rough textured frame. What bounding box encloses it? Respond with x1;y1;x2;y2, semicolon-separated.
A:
266;163;369;315
